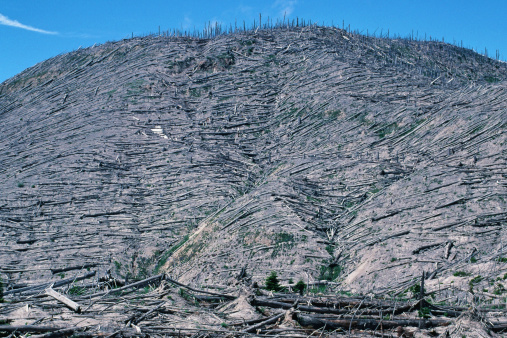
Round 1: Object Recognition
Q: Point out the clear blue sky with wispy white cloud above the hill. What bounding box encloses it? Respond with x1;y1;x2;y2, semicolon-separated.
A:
0;0;507;82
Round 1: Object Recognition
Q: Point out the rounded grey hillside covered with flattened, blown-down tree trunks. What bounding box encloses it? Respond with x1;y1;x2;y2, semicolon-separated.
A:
0;26;507;336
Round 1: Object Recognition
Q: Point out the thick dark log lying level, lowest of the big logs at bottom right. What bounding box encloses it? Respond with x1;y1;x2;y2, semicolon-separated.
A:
294;313;452;330
